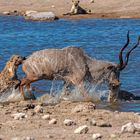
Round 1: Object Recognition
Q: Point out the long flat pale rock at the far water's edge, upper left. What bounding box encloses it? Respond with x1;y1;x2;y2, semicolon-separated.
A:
24;11;58;21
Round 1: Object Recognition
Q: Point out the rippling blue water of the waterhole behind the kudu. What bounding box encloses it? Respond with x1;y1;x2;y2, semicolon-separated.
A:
0;16;140;112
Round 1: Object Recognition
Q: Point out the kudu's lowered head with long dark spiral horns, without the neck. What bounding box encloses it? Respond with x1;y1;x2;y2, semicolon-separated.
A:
108;31;140;102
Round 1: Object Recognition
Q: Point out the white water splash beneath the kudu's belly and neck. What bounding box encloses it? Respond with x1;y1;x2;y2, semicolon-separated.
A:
37;80;109;104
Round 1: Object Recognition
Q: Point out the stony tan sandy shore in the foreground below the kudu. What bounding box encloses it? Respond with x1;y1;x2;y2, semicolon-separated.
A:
0;101;140;140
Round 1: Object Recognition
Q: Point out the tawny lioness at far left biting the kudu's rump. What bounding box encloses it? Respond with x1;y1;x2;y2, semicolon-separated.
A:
0;55;24;93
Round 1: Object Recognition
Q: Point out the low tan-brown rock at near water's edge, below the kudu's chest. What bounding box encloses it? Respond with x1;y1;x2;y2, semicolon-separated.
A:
71;102;96;113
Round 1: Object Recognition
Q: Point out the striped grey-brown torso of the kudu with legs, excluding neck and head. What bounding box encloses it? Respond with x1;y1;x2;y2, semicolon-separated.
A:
19;47;91;99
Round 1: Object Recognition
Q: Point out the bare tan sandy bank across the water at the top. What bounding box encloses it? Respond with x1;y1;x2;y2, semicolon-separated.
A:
0;0;140;19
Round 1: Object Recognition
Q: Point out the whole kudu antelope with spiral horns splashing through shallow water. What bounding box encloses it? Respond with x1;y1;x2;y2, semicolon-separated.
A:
20;32;140;102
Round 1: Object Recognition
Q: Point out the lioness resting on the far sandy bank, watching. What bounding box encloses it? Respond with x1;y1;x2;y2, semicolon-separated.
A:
64;0;88;15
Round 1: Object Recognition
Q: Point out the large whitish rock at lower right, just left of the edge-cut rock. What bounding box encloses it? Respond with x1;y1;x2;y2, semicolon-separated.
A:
121;122;136;133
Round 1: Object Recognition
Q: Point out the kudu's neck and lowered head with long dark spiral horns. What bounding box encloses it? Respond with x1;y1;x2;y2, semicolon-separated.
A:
87;32;140;102
